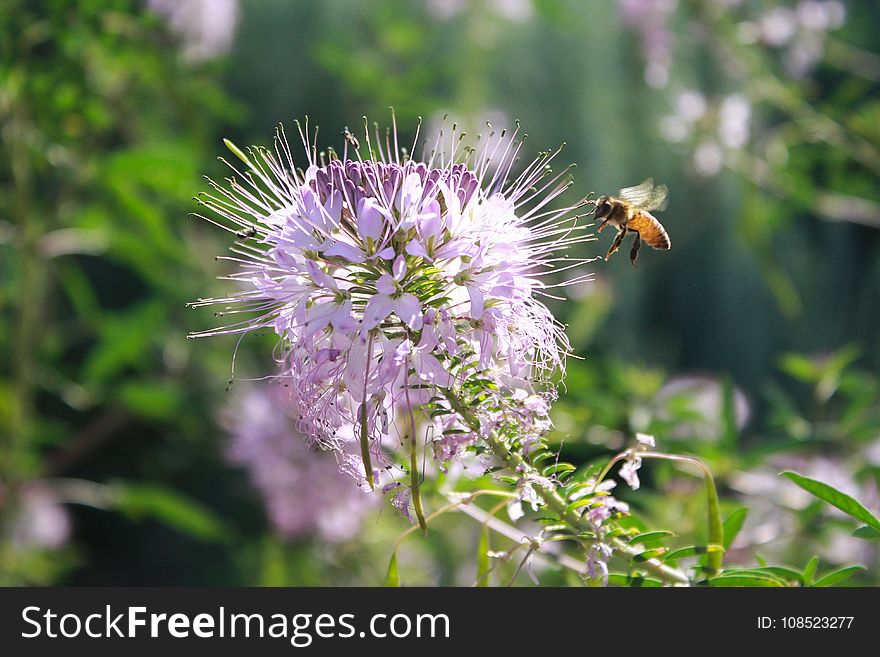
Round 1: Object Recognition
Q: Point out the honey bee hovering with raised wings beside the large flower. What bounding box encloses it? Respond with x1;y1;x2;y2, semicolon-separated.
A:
590;178;672;264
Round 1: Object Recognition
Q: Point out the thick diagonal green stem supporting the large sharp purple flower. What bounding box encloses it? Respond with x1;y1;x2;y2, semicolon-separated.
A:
444;390;690;584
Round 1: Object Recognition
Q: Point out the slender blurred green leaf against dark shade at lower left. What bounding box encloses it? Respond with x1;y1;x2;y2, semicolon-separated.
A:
112;482;229;541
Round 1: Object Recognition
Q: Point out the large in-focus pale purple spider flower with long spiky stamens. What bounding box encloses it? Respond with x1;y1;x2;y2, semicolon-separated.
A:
192;114;594;513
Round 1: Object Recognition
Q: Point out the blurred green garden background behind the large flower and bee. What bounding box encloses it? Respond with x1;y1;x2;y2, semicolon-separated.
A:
0;0;880;585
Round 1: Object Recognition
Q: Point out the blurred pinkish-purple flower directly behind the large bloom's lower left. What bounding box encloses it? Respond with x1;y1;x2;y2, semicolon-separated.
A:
223;384;377;543
